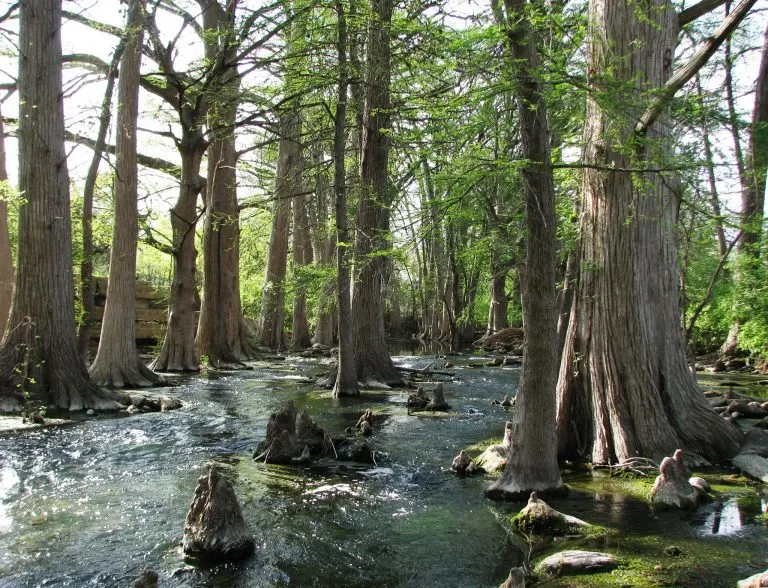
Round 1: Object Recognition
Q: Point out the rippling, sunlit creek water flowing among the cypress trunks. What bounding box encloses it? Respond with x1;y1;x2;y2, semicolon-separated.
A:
0;346;768;588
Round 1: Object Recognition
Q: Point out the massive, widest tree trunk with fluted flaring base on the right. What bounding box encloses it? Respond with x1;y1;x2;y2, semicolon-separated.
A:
557;0;739;464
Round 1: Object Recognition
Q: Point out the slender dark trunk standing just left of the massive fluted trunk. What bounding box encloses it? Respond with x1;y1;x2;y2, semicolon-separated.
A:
486;0;563;500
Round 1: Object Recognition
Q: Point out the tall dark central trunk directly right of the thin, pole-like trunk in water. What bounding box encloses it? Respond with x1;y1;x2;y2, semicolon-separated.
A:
354;0;402;385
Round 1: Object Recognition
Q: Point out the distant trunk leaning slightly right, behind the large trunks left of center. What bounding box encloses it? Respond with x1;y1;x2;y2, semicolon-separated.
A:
259;107;301;349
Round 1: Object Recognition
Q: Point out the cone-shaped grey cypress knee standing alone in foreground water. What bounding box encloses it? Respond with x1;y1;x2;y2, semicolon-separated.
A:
182;466;254;561
